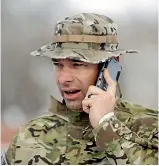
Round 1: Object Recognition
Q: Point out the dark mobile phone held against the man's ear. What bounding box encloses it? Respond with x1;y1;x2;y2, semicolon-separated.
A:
96;58;122;91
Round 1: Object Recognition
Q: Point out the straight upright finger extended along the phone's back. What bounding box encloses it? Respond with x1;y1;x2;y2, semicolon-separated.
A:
104;69;117;95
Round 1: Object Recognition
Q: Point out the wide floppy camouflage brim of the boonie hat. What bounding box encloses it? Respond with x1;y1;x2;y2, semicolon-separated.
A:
31;45;139;64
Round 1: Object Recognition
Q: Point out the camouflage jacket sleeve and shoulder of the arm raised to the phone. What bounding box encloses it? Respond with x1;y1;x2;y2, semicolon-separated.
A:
93;99;158;165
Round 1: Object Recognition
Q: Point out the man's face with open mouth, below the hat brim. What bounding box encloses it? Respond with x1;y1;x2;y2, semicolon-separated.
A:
53;59;98;111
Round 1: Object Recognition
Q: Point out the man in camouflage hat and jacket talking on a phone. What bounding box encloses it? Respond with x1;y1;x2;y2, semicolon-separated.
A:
3;13;158;165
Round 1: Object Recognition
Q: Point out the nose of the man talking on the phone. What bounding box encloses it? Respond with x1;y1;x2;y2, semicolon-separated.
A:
58;69;74;85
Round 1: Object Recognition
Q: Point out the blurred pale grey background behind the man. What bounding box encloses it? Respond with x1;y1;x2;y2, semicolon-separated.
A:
1;0;158;150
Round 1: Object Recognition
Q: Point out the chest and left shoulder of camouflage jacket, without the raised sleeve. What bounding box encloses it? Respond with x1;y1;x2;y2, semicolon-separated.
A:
7;98;108;165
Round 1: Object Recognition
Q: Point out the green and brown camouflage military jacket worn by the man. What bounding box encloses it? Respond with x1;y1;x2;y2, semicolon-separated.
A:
6;97;158;165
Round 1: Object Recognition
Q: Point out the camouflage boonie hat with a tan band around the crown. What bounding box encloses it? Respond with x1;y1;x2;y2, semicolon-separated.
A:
31;13;138;63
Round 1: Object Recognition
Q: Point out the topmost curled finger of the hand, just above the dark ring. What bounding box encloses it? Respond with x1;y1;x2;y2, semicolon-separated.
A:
86;85;105;98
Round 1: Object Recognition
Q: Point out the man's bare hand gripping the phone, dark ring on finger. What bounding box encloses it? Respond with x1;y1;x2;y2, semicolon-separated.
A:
82;69;116;128
